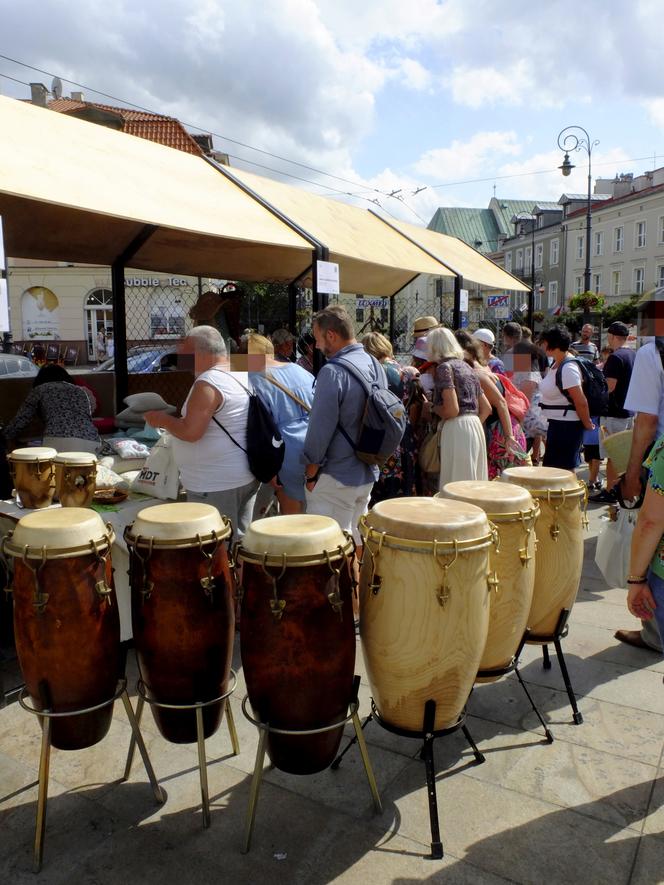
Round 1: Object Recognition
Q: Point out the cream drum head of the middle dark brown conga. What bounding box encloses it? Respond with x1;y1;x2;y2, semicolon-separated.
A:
129;501;231;546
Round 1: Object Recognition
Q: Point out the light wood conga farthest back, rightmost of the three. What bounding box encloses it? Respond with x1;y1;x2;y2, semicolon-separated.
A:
501;467;587;640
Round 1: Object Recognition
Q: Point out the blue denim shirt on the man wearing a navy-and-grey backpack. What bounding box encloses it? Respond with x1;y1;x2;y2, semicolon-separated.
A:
304;344;383;486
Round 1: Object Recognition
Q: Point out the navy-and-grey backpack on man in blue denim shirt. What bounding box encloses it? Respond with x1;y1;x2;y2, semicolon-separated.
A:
335;356;407;467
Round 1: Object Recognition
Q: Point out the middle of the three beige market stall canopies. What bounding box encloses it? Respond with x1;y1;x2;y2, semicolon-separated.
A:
220;168;454;295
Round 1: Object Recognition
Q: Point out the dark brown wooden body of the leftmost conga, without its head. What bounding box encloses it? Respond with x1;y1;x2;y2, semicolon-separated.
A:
13;554;124;750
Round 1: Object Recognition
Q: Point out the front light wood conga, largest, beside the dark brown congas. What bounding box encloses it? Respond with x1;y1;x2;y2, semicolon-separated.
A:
360;498;493;733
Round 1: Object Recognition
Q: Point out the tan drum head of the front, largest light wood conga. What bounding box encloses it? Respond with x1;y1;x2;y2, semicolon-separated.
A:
366;498;489;541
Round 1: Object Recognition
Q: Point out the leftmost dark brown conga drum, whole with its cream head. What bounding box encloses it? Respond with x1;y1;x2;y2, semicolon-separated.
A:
3;507;123;750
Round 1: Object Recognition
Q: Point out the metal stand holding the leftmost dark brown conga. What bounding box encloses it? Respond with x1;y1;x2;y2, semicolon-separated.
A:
18;679;166;873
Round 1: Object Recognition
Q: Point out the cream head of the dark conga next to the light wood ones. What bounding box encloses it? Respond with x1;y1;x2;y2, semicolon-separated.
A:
240;513;349;557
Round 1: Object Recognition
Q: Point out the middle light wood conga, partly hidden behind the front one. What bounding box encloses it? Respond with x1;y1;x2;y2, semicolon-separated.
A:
437;480;539;682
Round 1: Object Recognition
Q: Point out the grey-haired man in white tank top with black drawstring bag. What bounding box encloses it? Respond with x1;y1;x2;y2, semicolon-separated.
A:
145;326;259;538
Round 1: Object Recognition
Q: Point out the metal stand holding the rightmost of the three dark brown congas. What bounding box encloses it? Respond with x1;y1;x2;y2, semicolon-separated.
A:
242;675;383;854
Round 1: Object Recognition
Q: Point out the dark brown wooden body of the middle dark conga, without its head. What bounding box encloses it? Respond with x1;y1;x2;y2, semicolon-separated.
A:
129;542;235;744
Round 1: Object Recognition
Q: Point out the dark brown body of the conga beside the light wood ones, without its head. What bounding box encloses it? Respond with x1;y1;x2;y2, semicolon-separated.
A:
240;560;355;774
